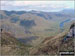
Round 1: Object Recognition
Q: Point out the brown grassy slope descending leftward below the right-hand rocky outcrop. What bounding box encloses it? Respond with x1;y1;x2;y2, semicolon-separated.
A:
30;32;73;55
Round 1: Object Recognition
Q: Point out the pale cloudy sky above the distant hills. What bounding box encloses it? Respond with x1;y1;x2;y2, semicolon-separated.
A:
1;1;74;11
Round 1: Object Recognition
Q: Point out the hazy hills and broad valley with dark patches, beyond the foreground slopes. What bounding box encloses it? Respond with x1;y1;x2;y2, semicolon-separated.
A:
0;9;75;45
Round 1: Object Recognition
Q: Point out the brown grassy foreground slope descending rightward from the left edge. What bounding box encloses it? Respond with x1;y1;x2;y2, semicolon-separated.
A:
1;32;30;55
